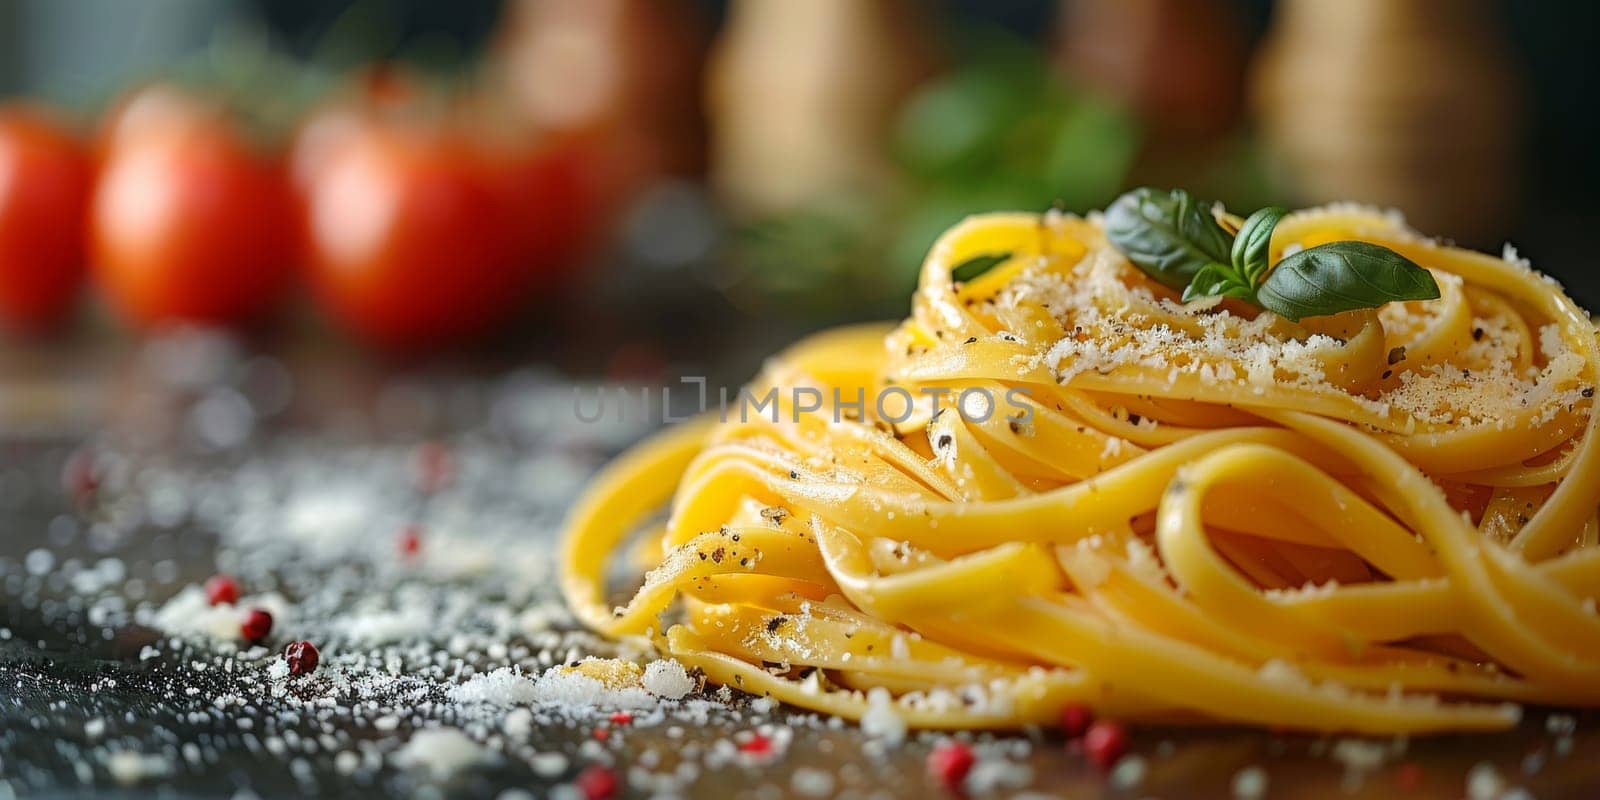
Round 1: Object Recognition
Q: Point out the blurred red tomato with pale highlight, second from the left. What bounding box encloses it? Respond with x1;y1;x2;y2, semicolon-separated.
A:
90;94;296;325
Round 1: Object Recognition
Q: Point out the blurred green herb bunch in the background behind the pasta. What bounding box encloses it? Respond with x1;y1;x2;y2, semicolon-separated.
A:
730;42;1142;315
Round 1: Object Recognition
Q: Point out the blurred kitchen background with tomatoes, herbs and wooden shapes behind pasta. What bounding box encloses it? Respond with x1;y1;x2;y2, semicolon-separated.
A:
0;0;1600;374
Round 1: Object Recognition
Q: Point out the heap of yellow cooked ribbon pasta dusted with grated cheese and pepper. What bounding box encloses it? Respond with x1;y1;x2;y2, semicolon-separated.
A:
563;206;1600;733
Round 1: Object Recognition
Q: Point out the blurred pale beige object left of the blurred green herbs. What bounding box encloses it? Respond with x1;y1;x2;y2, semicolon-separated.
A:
707;0;928;216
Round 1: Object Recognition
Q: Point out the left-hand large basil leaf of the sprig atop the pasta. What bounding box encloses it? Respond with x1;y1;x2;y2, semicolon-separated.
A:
1106;187;1232;290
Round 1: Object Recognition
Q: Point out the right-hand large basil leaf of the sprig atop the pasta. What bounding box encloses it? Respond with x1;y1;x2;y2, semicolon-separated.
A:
1256;242;1438;322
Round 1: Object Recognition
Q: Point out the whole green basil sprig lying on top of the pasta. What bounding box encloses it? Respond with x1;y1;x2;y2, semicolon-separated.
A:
1106;187;1438;322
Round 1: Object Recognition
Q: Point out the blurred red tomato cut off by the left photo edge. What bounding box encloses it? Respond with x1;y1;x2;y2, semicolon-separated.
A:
0;107;91;331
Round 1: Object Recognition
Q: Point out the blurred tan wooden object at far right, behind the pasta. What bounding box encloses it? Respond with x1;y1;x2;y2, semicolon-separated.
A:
1251;0;1518;245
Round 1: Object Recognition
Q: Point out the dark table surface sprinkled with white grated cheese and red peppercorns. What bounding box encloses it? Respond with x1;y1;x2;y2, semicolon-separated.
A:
0;326;1600;798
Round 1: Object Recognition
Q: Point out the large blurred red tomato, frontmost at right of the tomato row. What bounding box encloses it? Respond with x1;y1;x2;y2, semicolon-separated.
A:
306;123;528;349
